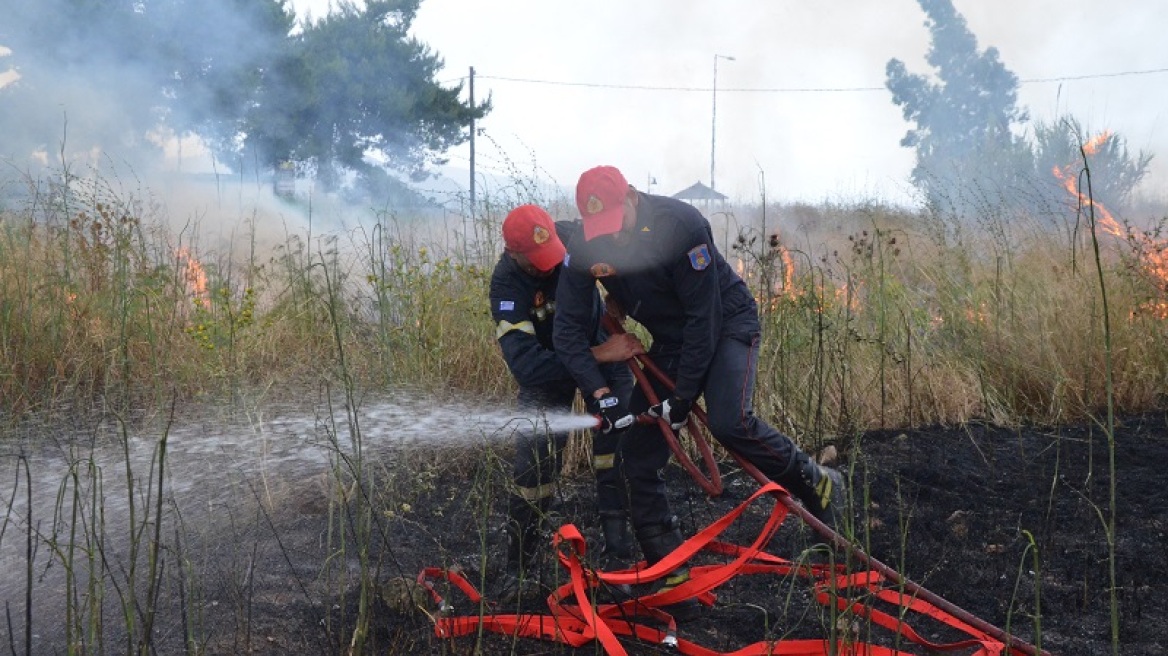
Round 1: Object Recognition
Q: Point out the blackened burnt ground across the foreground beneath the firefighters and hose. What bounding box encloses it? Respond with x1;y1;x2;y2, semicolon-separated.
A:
4;414;1168;656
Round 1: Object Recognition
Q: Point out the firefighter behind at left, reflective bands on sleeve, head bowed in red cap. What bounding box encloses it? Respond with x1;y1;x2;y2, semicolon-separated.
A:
491;204;645;603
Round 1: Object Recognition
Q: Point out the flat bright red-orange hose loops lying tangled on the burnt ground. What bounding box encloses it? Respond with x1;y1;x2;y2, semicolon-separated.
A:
418;483;1023;656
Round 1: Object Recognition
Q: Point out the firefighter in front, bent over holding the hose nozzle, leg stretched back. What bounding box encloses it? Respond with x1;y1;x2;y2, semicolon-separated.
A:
555;166;843;620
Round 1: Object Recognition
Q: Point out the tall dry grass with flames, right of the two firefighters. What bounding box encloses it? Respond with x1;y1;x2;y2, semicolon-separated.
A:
736;198;1168;435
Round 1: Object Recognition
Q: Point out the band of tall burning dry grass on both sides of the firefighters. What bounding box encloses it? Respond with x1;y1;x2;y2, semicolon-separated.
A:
0;164;1168;429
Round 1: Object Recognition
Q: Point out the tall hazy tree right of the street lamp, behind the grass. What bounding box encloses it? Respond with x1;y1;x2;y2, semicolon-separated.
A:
885;0;1152;214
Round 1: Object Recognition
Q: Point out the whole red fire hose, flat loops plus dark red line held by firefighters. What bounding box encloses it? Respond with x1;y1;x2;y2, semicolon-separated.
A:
417;315;1050;656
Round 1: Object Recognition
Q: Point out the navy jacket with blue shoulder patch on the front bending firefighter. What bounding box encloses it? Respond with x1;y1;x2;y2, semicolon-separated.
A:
555;194;758;400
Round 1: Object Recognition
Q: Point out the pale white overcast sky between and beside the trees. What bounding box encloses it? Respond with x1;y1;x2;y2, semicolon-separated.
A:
293;0;1168;202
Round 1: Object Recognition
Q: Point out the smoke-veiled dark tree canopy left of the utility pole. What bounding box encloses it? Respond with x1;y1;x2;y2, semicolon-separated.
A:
0;0;491;193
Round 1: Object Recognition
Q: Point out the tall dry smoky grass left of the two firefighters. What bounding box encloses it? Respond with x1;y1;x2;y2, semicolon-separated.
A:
0;166;506;414
